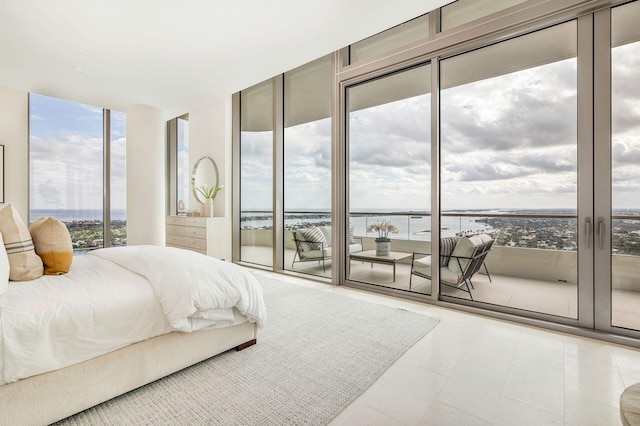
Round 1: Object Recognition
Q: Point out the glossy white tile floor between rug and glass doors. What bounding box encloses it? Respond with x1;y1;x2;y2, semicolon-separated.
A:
254;271;640;426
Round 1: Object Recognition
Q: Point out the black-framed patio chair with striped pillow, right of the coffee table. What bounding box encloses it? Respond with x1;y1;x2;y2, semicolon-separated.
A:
409;234;493;300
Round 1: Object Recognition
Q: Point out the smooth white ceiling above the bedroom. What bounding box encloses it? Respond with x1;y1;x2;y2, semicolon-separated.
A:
0;0;451;118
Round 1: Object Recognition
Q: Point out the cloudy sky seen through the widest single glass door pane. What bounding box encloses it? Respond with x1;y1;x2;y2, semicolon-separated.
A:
441;58;578;210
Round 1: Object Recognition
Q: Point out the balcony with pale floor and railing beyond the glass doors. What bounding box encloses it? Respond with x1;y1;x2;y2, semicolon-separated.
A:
241;213;640;330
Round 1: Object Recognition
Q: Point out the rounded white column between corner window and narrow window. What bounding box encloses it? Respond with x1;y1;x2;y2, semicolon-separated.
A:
126;105;166;245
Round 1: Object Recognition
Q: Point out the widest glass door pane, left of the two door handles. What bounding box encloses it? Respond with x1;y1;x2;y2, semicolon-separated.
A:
440;21;578;318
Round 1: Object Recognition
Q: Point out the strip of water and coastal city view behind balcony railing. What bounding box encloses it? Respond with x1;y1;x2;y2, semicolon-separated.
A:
241;209;640;256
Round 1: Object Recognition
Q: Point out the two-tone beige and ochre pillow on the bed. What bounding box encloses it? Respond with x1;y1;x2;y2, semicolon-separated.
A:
29;217;73;275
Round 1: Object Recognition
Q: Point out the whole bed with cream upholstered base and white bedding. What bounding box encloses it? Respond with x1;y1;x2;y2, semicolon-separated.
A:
0;246;266;425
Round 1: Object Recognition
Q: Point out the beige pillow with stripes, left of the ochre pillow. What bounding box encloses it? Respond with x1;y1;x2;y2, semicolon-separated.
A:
0;204;43;281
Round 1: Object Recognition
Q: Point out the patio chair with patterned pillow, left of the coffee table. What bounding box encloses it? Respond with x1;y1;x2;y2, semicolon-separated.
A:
291;226;363;272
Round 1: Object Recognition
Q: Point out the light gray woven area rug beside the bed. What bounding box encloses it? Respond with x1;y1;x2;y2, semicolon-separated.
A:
57;277;438;425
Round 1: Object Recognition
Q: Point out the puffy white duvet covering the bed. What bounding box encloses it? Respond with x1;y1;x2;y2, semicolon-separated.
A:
0;246;266;384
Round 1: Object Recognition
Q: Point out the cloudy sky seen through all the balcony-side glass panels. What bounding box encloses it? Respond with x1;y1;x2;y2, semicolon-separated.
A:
242;36;640;211
